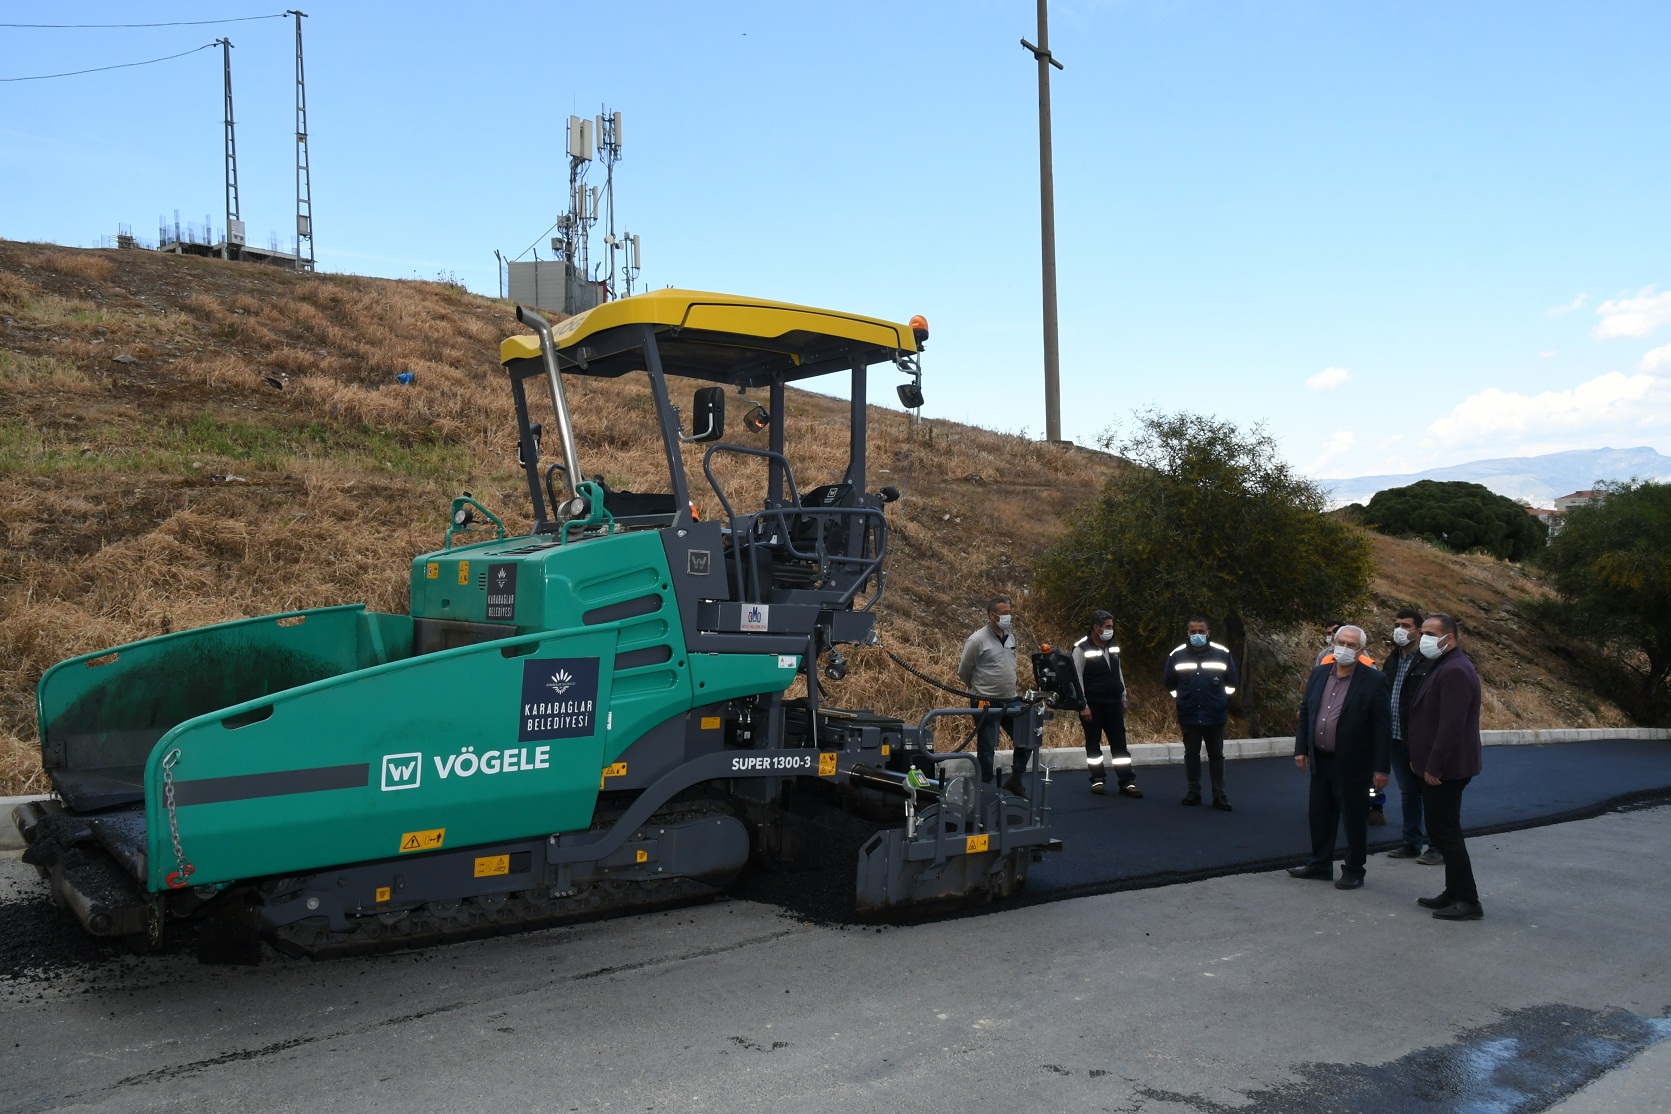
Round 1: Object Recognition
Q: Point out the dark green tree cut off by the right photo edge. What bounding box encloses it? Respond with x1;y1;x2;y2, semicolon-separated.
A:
1544;481;1671;718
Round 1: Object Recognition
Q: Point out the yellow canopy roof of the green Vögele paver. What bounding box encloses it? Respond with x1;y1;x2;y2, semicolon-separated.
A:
500;291;917;382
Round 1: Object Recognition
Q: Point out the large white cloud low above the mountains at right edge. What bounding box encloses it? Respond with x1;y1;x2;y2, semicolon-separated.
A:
1427;370;1671;453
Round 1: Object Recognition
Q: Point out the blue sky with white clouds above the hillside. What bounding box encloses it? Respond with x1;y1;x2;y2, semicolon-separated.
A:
0;0;1671;476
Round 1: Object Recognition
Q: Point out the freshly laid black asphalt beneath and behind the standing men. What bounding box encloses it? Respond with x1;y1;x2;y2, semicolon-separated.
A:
1021;740;1671;904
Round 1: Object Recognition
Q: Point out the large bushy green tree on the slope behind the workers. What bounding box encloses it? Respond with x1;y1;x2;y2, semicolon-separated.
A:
1039;413;1374;731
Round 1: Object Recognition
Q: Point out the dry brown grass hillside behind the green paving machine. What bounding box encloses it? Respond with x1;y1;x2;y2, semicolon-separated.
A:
0;242;1623;793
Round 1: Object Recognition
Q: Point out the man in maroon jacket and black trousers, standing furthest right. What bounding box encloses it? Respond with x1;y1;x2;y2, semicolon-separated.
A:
1405;615;1486;920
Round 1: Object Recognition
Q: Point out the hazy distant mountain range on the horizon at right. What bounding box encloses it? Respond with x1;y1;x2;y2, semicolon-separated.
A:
1317;446;1671;506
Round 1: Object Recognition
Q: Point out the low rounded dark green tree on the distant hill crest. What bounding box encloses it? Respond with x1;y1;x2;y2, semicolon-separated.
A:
1364;479;1547;561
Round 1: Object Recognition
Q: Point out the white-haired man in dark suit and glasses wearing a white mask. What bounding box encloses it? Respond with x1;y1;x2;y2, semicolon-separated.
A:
1288;626;1392;890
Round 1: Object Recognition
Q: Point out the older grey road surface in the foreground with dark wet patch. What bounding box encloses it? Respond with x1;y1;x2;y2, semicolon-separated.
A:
0;802;1671;1114
